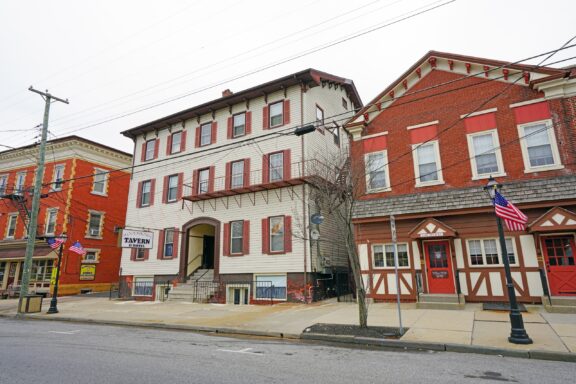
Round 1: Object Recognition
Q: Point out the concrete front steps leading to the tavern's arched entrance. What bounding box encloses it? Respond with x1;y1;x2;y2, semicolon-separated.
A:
168;269;217;303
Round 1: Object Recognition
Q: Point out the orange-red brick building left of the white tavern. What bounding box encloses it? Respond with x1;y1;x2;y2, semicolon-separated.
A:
0;136;132;296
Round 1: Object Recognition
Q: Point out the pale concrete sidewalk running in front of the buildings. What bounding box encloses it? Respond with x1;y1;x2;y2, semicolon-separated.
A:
0;296;576;361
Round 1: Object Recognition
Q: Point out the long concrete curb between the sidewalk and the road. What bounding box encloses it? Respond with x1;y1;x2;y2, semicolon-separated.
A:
0;313;576;363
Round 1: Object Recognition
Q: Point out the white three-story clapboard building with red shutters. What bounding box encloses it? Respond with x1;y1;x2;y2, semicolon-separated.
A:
121;69;361;304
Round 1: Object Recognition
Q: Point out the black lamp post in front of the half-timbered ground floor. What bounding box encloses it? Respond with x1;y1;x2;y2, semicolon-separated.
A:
484;176;532;344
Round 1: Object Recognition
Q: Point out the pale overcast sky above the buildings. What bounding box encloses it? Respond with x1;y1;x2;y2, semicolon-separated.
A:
0;0;576;152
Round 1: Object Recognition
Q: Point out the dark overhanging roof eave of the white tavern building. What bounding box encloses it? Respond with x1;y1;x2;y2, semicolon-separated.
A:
122;68;362;138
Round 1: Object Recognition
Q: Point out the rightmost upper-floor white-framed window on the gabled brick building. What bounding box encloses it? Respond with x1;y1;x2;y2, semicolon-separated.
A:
518;120;561;172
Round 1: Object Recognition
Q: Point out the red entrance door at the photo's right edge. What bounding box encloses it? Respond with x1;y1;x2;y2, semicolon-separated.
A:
542;236;576;296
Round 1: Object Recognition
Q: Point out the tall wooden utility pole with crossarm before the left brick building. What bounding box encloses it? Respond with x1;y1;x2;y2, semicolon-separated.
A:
18;86;68;314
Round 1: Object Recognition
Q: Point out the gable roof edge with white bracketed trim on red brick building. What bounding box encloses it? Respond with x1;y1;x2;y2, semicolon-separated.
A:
344;51;571;128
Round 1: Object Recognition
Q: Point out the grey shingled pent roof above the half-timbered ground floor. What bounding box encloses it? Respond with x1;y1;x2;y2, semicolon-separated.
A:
354;176;576;219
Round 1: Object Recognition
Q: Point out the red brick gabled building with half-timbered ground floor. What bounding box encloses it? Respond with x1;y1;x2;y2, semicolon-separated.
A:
346;51;576;302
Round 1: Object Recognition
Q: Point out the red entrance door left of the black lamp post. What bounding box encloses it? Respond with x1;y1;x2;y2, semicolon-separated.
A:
424;241;456;293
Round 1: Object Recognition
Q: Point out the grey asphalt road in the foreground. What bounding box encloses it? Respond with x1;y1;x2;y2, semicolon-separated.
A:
0;319;576;384
